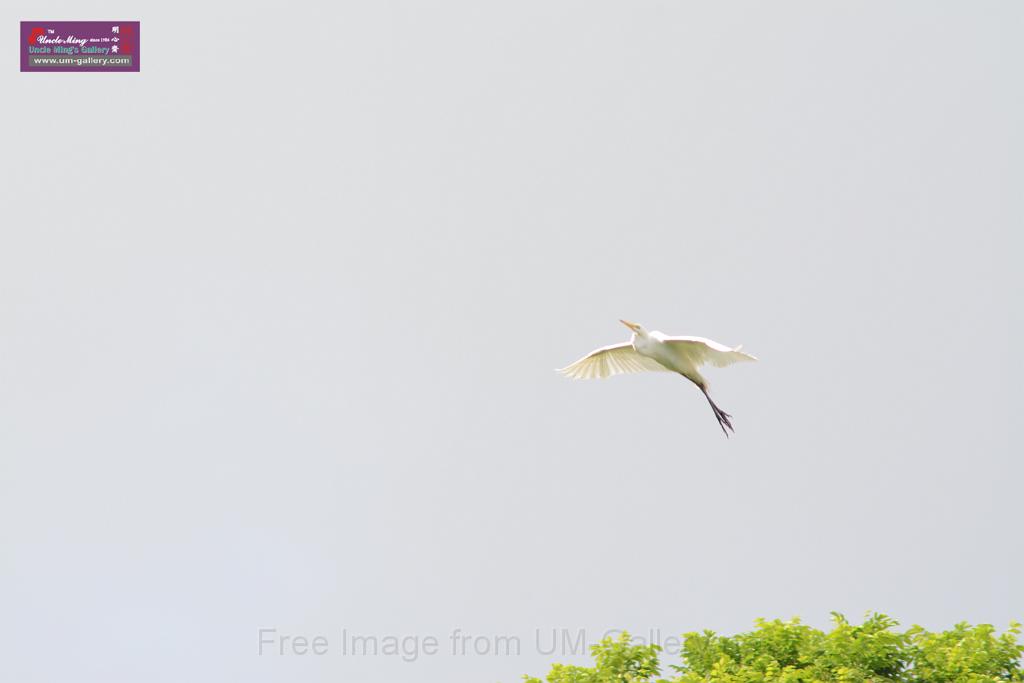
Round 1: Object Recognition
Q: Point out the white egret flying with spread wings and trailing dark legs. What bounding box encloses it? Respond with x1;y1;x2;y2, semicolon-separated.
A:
558;321;757;436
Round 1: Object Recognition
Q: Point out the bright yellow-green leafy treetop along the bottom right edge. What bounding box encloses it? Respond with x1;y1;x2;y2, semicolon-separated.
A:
525;612;1024;683
